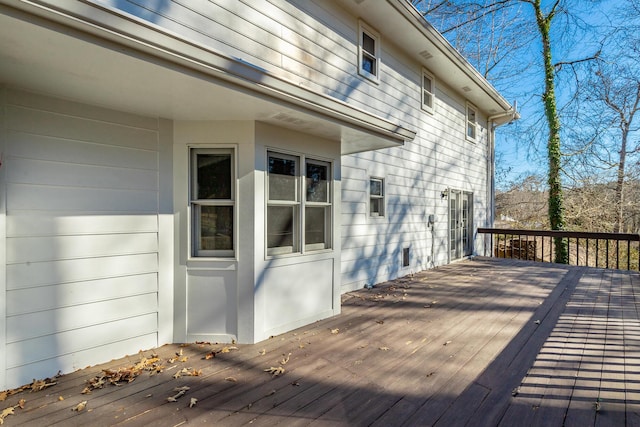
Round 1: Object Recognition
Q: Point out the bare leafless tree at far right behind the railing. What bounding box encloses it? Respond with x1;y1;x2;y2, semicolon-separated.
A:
569;0;640;232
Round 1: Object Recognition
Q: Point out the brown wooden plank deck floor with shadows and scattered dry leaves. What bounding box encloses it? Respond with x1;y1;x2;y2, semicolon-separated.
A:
0;258;640;426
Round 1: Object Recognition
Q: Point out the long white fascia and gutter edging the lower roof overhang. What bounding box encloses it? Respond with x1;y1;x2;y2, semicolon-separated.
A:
0;0;417;146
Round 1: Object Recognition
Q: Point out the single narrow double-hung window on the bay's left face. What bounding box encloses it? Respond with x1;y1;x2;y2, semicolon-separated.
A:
189;149;235;257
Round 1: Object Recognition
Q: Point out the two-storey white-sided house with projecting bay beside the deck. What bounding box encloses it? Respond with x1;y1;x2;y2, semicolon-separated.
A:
0;0;516;389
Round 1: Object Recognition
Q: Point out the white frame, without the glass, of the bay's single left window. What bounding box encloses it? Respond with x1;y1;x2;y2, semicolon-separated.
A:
189;147;237;258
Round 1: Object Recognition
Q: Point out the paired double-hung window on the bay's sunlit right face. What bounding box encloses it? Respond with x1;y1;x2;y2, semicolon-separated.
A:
266;152;332;255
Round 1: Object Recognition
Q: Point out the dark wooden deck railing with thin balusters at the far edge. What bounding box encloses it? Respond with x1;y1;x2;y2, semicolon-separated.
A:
478;228;640;270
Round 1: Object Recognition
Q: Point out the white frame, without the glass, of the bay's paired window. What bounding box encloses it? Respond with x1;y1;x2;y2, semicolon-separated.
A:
265;149;333;257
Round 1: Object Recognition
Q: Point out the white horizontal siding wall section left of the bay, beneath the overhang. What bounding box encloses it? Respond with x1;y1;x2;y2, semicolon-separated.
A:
3;91;159;392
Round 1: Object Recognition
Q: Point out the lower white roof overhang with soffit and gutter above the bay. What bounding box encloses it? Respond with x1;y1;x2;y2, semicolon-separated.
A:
0;0;416;154
